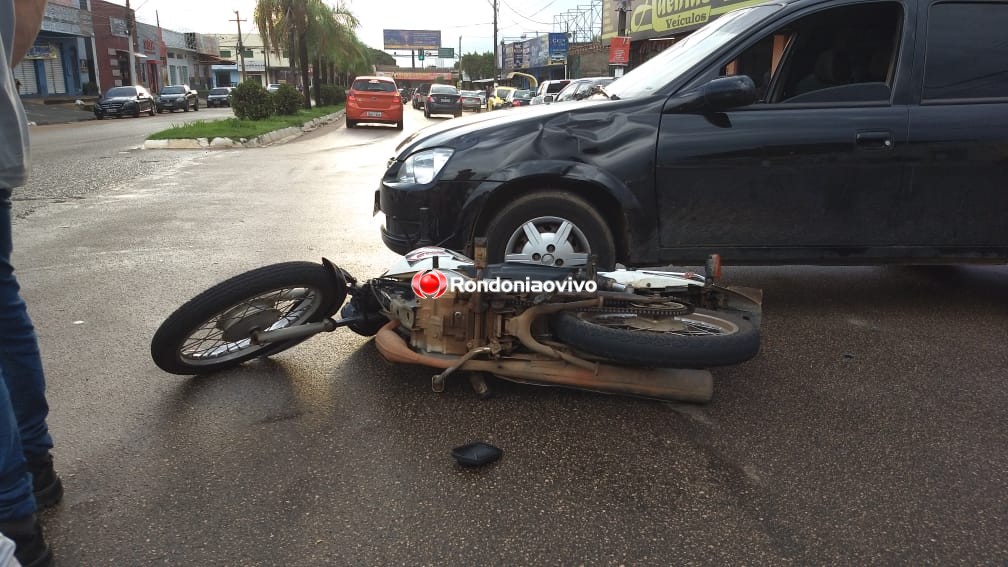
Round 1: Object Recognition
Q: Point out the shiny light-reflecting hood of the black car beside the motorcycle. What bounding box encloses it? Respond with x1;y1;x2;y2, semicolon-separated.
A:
395;100;623;160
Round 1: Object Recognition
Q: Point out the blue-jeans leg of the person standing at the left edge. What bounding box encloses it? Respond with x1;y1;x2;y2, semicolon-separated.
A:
0;189;62;507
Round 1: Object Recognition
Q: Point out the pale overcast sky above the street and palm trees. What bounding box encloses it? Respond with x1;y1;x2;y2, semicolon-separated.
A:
110;0;589;65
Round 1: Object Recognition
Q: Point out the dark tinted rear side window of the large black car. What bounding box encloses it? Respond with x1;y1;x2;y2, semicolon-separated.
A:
923;2;1008;101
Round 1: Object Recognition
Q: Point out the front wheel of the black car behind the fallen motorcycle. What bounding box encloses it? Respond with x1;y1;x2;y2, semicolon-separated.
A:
484;190;616;269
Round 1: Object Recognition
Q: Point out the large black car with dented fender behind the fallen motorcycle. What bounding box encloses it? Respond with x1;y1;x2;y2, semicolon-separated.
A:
375;0;1008;266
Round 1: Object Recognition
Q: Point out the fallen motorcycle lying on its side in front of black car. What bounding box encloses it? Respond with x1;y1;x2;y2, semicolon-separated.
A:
151;242;761;402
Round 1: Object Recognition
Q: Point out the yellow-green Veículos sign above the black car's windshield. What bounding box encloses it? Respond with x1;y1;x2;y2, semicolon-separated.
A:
602;0;762;41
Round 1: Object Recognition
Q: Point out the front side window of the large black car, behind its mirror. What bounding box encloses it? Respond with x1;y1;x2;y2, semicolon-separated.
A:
720;2;903;103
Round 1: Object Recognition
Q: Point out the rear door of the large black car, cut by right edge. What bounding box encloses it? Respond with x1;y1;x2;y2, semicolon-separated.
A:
905;0;1008;249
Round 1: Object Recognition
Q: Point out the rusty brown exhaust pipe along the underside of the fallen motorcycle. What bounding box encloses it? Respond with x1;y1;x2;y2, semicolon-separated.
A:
375;322;714;403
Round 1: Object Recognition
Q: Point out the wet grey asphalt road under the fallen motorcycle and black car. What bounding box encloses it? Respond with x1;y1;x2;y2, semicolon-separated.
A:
9;107;1008;565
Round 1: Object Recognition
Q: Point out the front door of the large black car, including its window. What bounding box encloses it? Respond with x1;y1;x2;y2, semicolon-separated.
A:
655;1;914;263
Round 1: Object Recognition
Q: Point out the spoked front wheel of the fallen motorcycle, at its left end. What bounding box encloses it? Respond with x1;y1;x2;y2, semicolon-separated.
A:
150;261;347;374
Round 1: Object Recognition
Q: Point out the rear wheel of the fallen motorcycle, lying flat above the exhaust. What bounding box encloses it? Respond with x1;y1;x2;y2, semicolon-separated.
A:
551;309;760;368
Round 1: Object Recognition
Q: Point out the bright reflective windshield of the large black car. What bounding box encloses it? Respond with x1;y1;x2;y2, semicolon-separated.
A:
606;4;781;99
